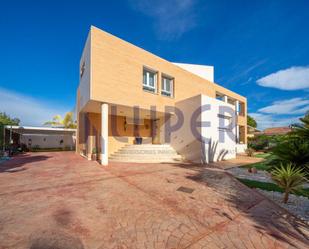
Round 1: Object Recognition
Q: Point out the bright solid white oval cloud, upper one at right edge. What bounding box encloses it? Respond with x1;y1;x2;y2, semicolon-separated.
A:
257;66;309;90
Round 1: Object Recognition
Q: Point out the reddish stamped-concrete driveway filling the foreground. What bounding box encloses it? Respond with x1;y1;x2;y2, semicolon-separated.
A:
0;152;309;249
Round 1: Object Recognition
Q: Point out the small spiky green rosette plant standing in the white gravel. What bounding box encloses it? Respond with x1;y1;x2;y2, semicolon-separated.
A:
271;163;306;203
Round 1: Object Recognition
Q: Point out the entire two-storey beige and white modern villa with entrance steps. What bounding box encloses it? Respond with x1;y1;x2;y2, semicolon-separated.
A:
76;26;247;165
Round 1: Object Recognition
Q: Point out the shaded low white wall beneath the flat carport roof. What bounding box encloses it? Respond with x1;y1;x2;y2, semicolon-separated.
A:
20;135;75;149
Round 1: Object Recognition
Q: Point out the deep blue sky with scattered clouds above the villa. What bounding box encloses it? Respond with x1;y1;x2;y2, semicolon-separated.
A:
0;0;309;128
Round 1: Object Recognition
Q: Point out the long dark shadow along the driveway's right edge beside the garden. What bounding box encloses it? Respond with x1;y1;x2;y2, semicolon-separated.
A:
174;164;309;248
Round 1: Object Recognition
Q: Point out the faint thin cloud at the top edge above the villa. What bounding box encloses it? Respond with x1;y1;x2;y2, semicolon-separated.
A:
129;0;196;40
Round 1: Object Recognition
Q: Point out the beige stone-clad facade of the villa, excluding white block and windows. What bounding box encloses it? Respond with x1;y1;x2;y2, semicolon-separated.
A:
76;26;247;164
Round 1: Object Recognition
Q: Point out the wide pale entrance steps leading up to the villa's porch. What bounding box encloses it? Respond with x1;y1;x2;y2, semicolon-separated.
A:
109;144;182;163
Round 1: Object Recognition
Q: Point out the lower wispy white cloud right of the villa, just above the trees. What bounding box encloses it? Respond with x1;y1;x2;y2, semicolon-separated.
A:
258;98;309;115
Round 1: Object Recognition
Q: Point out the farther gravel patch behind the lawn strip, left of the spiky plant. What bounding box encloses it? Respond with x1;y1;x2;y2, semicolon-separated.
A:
227;167;309;188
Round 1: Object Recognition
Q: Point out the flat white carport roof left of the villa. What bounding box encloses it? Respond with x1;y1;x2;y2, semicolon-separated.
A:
5;125;76;135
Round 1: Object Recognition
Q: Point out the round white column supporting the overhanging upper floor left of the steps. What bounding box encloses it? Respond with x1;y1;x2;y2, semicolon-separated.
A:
101;103;108;165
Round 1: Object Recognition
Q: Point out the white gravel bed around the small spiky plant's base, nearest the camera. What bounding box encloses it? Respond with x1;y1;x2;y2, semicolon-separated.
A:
256;189;309;225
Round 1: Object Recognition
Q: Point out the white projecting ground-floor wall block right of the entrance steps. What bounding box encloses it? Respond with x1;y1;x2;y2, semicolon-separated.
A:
165;95;236;163
